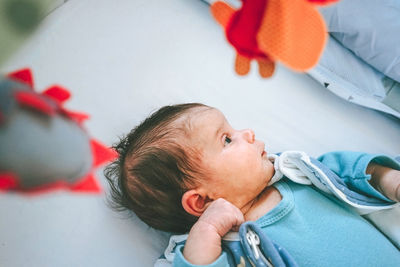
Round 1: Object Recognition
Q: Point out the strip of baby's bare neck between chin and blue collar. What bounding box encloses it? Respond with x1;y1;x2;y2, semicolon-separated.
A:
242;186;282;221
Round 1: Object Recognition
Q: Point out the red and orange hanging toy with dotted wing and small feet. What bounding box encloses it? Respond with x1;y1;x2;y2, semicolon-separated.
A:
211;0;338;78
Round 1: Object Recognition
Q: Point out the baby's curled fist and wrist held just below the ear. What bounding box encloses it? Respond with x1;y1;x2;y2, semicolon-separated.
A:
183;198;244;265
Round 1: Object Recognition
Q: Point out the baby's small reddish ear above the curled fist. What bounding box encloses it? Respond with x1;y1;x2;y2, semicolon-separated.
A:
182;189;212;217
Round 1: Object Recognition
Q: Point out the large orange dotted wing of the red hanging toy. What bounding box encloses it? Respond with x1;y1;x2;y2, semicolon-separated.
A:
257;0;327;71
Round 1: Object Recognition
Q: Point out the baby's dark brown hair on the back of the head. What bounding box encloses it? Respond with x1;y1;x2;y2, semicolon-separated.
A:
104;103;210;233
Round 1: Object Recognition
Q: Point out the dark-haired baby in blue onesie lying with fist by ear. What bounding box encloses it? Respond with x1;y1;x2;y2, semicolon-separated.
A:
105;103;400;266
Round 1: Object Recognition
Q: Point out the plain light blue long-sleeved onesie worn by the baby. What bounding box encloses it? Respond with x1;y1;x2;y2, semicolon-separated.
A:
173;152;400;266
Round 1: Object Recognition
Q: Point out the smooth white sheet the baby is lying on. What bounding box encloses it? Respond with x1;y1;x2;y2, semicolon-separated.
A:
0;0;400;267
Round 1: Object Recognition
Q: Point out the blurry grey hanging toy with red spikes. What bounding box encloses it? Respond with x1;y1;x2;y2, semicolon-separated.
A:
0;69;116;194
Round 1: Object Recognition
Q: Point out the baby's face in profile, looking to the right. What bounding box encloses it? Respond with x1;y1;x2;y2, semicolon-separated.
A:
190;108;275;208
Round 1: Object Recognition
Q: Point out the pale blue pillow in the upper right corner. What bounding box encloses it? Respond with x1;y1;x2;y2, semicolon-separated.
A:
320;0;400;82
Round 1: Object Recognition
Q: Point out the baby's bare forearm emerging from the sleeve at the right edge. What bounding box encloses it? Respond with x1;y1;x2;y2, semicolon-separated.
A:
367;162;400;202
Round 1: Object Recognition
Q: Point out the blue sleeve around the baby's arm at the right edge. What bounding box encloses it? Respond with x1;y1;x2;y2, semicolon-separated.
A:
318;151;400;202
